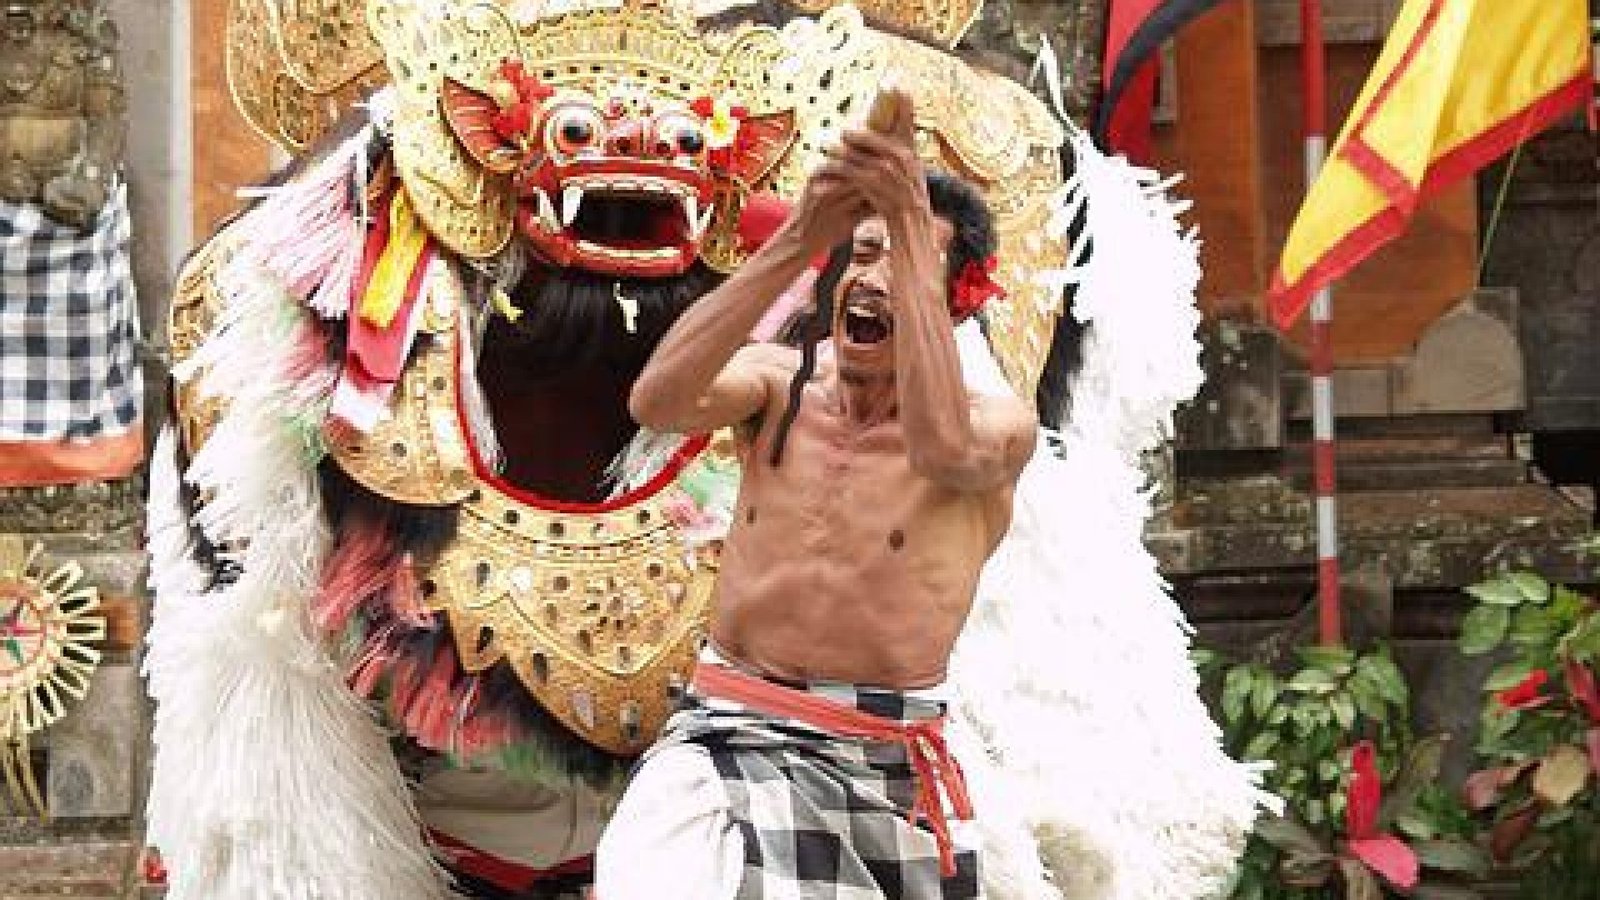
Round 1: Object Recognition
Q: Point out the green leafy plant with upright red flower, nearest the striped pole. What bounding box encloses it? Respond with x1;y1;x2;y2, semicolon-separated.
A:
1197;647;1488;900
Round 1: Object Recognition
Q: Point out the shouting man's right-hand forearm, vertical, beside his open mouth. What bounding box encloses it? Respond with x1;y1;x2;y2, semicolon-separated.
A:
888;210;973;471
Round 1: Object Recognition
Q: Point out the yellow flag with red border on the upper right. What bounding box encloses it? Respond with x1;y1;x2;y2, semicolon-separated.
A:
1269;0;1594;327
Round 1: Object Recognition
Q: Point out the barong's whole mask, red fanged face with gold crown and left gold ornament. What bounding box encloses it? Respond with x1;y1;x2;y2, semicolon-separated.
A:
370;0;797;279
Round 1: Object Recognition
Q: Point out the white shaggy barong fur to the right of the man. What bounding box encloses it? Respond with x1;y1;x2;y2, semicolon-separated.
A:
950;135;1267;900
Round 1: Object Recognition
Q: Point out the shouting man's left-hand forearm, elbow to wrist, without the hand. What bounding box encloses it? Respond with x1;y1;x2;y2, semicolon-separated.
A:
630;224;810;421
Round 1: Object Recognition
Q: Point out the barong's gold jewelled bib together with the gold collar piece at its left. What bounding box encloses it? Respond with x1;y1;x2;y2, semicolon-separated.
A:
325;264;715;756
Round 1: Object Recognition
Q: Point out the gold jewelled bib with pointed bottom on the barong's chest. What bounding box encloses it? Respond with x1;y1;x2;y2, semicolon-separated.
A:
424;485;712;754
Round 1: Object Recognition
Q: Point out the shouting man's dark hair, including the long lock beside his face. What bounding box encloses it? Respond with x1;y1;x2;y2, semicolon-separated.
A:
771;170;998;466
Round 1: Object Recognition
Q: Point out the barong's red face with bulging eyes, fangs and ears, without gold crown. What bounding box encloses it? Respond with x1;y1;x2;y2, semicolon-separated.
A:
442;61;794;279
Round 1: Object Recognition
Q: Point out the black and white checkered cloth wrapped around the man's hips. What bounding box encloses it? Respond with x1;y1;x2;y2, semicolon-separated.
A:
658;662;981;900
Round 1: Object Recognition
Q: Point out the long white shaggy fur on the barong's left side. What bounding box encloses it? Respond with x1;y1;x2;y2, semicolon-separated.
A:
144;256;448;900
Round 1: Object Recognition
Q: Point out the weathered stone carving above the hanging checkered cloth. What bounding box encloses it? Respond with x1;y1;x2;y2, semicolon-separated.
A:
0;0;126;226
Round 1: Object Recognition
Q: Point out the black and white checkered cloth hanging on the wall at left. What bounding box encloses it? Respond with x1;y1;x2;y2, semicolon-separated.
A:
0;183;144;442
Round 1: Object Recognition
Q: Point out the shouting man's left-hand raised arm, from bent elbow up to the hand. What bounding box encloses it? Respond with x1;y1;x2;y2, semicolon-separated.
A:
629;174;864;432
